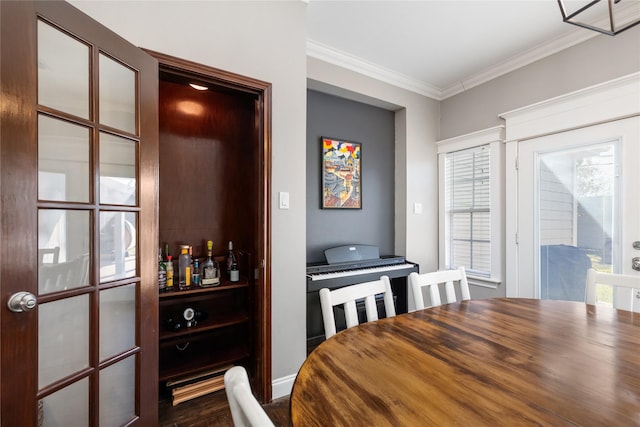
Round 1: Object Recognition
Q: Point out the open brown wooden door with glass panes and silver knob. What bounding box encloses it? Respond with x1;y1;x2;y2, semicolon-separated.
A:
0;1;158;426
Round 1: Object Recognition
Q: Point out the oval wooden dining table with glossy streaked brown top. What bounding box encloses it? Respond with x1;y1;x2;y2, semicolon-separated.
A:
290;298;640;427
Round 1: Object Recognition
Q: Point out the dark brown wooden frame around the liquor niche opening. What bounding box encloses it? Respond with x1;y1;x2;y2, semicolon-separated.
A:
144;49;272;403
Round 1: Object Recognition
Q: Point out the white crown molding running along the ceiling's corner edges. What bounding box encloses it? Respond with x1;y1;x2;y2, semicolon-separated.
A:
307;28;600;101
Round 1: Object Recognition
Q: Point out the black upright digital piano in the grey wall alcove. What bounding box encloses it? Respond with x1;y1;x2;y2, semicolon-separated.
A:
307;245;419;353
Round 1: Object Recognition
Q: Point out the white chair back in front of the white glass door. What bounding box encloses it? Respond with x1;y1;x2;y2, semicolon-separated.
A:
585;268;640;312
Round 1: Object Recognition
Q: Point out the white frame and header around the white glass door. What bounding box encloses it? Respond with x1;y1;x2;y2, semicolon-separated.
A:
499;72;640;298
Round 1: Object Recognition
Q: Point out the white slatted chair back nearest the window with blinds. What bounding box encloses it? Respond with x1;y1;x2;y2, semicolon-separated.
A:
409;267;471;310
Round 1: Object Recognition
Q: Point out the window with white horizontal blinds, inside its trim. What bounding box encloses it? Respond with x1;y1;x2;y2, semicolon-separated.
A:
444;144;491;277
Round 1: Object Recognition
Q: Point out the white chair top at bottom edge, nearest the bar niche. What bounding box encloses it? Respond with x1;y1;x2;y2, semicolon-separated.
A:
224;366;273;427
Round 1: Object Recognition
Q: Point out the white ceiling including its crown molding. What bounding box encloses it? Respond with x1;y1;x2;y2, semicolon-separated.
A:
303;0;640;100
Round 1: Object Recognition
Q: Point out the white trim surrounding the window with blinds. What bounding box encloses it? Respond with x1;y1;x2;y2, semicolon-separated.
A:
436;126;504;289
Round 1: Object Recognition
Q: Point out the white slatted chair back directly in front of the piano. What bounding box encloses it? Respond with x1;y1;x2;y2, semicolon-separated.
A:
320;276;396;339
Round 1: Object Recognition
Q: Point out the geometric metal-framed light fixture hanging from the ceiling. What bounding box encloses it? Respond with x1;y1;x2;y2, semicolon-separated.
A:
558;0;640;36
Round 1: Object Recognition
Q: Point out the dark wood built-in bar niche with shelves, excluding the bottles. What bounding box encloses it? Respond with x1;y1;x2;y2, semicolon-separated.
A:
148;51;271;401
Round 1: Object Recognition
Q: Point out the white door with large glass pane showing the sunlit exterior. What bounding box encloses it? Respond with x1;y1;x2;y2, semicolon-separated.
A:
516;116;640;301
